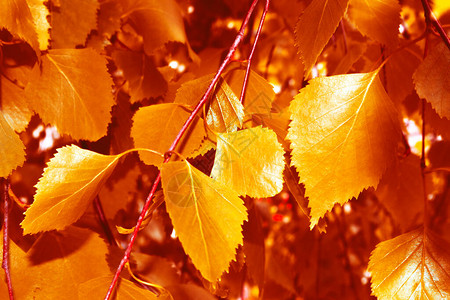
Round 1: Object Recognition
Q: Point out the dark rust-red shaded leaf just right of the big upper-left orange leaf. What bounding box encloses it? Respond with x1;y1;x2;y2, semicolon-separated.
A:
112;50;167;103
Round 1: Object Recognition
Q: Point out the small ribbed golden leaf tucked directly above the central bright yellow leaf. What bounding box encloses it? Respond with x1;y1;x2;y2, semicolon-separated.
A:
206;81;244;132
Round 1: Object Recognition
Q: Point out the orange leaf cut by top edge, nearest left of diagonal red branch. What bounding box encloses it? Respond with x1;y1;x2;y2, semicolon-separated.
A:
121;0;187;55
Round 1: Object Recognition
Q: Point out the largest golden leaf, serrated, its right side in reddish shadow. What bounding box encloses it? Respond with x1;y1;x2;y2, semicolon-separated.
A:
287;70;401;228
